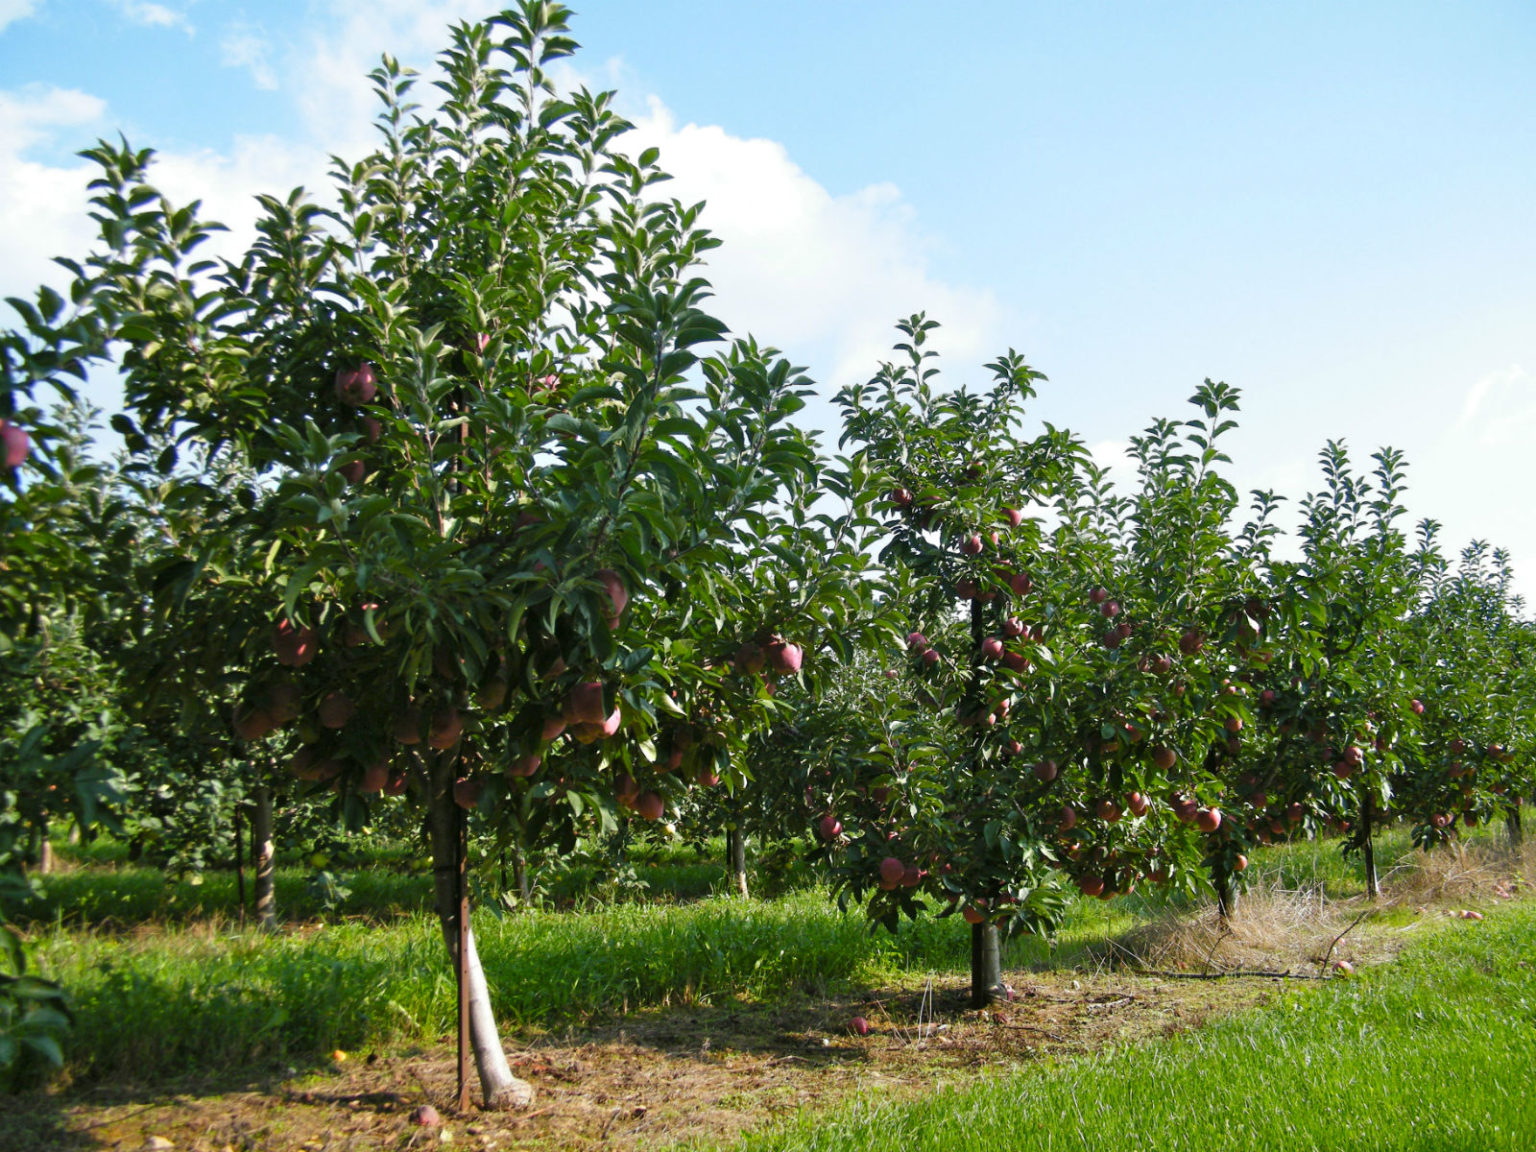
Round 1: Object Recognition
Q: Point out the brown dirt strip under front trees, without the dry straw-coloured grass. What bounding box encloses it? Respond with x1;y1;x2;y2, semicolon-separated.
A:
0;972;1345;1152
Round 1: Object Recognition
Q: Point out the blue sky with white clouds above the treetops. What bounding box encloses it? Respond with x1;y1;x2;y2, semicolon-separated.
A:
0;0;1536;593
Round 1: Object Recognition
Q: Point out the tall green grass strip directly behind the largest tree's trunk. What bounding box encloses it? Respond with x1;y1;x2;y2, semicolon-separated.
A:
35;891;969;1080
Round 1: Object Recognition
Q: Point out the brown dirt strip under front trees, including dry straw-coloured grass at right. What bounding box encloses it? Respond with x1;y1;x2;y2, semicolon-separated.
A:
0;857;1533;1152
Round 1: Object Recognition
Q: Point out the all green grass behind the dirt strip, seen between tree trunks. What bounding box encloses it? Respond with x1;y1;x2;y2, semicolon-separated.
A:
14;836;1499;1081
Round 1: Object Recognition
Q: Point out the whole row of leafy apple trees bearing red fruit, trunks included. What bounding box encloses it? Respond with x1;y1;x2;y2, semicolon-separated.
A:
0;0;1536;1106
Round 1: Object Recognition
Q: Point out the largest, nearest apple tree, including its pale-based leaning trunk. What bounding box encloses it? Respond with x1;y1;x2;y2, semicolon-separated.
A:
51;0;866;1107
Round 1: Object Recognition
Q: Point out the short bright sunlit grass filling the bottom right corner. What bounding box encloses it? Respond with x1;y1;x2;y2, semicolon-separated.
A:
721;905;1536;1152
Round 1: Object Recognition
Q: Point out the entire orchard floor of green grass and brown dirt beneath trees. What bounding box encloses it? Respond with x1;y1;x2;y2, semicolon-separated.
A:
0;831;1536;1152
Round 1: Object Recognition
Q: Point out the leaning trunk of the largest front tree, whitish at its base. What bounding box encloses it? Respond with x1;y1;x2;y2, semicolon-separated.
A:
427;754;533;1109
